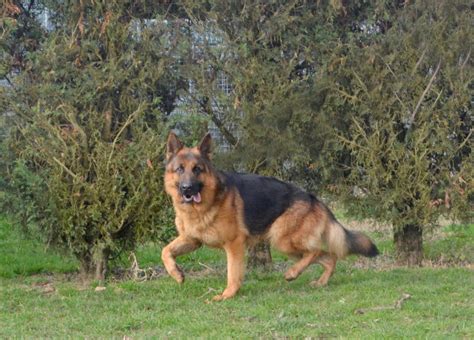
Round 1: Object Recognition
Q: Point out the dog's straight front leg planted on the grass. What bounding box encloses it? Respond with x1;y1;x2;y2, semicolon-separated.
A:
213;237;245;301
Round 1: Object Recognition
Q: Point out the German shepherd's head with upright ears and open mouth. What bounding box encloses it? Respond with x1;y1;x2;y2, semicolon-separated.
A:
165;132;215;205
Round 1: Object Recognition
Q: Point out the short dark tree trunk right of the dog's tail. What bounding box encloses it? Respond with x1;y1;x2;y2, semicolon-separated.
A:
394;224;423;266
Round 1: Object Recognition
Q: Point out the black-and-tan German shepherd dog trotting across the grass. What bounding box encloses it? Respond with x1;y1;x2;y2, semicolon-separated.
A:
162;133;378;301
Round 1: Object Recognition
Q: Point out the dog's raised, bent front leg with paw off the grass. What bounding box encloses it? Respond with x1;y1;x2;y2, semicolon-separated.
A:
161;235;201;283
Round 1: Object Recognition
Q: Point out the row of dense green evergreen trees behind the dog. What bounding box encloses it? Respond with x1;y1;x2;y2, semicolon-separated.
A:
0;0;474;272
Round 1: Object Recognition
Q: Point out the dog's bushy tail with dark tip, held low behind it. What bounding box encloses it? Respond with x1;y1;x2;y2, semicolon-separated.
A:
327;221;379;258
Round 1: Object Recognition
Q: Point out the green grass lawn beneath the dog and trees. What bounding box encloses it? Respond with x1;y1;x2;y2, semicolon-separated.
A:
0;216;474;338
